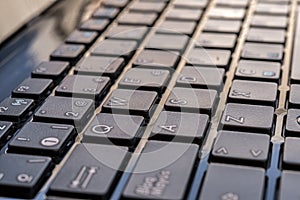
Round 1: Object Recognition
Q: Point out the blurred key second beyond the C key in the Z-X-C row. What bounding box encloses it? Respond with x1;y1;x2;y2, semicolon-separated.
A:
247;28;285;43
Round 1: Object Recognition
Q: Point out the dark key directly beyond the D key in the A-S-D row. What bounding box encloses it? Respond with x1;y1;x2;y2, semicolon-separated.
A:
187;48;231;68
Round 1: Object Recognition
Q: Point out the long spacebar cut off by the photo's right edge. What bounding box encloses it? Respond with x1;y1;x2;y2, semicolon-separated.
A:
291;13;300;83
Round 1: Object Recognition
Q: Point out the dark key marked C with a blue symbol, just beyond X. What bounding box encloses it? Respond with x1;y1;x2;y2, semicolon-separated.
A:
235;60;280;82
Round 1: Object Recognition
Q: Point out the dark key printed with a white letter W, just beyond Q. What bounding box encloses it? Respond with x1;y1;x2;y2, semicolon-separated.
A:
103;89;158;118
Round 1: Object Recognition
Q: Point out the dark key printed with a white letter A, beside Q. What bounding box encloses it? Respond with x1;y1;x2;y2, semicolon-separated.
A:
151;111;209;144
